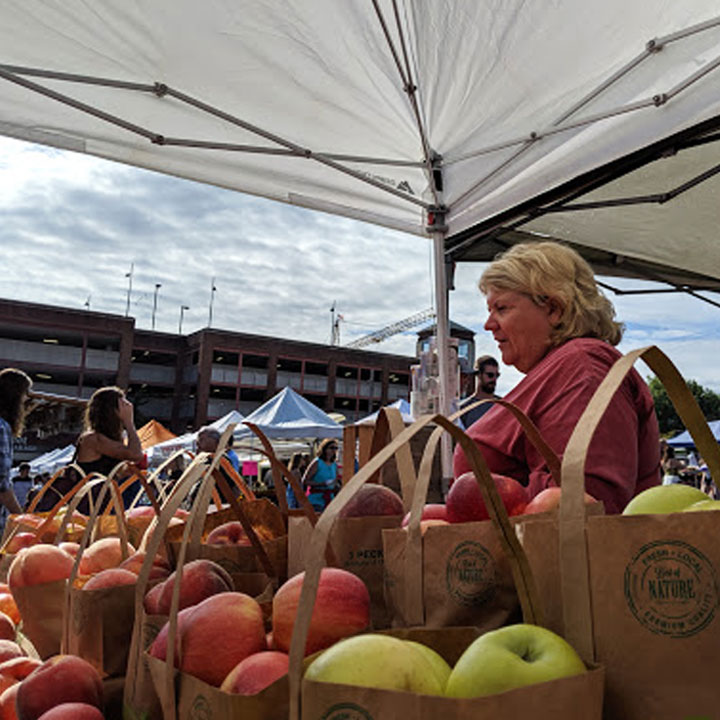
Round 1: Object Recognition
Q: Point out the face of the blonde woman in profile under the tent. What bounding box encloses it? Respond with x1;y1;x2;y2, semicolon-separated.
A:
484;288;561;373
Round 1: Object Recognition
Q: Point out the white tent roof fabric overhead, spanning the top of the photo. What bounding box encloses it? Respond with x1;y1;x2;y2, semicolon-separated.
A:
0;0;720;285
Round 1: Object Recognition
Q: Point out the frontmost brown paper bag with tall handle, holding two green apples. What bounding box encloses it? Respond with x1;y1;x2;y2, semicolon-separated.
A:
290;416;603;720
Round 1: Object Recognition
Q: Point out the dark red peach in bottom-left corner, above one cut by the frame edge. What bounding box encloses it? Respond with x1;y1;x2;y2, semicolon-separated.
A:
16;655;103;720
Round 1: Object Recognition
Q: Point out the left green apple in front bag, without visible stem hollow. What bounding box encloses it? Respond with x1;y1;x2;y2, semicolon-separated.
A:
305;633;443;695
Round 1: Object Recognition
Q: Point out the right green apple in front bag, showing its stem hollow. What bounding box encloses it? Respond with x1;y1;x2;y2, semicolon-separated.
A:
445;624;586;698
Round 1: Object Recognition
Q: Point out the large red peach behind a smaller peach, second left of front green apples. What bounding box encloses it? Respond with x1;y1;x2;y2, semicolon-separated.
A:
150;592;265;687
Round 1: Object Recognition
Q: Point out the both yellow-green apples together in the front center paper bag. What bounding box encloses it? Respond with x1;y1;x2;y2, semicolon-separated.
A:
305;624;587;698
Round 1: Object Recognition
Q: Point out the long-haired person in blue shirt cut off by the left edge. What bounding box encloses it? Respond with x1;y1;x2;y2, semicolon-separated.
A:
0;368;32;513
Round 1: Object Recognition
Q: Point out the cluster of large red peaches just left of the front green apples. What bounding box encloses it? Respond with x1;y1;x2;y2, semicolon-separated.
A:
145;560;370;695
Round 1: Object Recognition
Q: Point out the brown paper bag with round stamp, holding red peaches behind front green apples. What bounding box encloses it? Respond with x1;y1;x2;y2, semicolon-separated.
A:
383;400;560;630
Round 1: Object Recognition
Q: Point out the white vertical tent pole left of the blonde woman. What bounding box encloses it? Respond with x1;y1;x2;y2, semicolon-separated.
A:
428;208;452;497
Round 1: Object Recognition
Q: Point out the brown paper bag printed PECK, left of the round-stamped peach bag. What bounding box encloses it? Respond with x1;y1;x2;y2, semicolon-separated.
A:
288;408;416;629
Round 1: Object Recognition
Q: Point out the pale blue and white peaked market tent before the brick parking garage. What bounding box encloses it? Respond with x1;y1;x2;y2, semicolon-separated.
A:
235;387;342;441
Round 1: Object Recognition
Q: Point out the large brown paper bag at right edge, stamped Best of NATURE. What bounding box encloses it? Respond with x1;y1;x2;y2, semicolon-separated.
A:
527;347;720;720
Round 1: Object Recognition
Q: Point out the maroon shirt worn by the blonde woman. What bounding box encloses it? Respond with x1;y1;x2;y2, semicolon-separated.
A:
453;338;660;513
